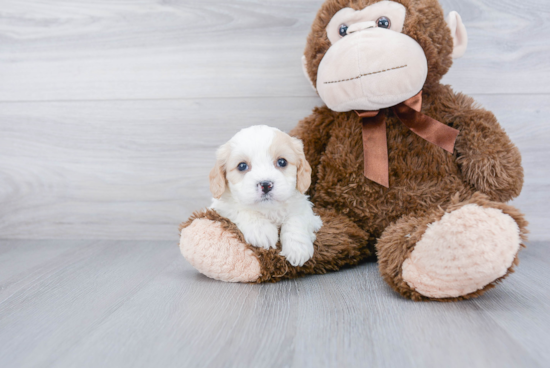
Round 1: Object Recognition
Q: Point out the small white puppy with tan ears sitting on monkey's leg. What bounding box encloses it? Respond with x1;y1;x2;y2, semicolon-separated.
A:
210;125;323;266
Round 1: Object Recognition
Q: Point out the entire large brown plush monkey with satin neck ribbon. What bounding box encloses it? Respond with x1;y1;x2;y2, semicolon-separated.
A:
180;0;527;301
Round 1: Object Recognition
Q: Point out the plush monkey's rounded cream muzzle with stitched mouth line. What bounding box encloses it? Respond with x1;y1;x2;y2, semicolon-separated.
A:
317;27;428;112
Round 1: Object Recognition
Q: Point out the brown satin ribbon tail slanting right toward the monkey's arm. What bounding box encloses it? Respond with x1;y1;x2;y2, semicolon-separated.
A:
393;103;459;153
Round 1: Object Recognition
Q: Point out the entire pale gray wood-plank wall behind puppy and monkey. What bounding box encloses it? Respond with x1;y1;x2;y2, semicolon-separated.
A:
0;0;550;240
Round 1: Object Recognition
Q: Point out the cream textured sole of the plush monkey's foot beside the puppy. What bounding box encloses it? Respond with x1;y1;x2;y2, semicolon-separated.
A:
180;218;261;282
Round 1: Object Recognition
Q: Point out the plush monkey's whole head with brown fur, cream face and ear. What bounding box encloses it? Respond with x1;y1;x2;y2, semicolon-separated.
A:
303;0;467;112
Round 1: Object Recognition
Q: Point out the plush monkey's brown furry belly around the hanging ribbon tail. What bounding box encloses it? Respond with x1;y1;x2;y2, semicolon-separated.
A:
312;114;474;237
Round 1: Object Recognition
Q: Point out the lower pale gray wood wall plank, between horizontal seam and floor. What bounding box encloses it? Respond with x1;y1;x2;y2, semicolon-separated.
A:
0;95;550;241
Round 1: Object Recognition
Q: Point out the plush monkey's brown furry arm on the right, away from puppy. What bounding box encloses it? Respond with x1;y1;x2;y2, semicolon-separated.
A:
443;88;523;202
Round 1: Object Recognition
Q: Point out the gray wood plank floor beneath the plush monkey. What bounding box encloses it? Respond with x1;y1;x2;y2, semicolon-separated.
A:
0;240;550;368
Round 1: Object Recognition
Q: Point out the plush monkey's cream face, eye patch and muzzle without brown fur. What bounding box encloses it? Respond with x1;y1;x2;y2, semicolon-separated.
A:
317;1;428;111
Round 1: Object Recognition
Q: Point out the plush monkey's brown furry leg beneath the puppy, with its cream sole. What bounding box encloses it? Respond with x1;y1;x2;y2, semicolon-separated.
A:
180;209;374;283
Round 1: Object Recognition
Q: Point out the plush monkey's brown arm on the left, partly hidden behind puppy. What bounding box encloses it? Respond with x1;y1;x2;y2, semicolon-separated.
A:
290;107;334;197
